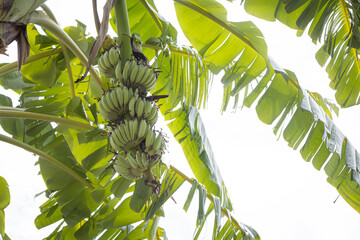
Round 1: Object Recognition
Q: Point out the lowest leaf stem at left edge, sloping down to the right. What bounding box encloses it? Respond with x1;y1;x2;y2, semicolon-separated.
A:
0;134;94;190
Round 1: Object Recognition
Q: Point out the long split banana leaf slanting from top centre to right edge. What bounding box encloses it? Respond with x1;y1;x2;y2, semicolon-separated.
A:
175;0;360;211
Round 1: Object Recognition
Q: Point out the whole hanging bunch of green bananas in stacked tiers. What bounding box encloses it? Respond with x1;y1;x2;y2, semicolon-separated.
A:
98;45;165;190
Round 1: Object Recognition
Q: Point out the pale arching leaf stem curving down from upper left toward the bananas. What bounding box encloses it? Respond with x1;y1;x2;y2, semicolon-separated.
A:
29;12;105;88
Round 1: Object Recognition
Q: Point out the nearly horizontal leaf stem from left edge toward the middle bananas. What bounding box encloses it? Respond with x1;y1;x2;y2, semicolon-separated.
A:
0;107;95;130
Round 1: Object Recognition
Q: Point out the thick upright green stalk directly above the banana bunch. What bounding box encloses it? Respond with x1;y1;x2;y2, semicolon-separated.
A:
114;0;132;68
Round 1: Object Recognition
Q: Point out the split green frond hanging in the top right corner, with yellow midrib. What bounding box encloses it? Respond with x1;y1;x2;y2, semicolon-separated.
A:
245;0;360;107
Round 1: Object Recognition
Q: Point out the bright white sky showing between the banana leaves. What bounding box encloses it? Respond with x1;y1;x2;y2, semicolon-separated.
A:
0;0;360;240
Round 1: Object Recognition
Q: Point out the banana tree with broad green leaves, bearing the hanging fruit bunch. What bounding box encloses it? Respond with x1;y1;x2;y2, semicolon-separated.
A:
0;0;360;239
